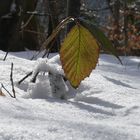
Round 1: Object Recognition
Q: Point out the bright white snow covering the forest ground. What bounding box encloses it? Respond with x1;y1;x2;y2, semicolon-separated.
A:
0;51;140;140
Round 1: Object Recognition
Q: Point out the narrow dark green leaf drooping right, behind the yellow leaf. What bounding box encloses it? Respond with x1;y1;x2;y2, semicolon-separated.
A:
80;19;122;64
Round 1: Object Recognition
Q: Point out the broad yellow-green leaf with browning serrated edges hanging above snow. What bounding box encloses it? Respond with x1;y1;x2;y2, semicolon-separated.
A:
60;24;99;88
